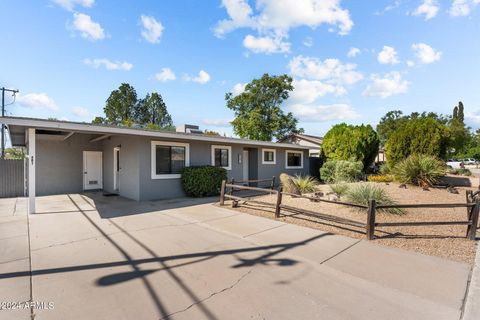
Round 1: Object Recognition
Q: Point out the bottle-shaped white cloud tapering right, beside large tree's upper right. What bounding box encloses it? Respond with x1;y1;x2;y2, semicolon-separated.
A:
290;79;347;104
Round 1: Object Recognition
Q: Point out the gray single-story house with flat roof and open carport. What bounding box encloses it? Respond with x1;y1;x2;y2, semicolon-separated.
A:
0;117;309;212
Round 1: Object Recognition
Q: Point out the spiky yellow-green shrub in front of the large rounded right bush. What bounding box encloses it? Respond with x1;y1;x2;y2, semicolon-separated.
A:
393;154;445;186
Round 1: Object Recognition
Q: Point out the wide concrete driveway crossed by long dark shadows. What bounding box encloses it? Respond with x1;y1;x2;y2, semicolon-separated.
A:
0;194;470;320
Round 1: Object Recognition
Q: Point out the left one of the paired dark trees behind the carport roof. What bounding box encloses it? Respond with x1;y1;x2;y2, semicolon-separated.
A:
103;83;137;126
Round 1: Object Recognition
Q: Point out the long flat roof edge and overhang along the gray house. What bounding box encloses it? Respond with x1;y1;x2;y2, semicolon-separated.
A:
0;117;309;150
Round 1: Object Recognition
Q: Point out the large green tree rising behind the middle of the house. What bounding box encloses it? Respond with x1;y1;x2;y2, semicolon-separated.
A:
225;74;303;141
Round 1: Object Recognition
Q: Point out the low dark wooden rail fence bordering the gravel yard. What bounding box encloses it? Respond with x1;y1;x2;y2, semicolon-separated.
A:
220;180;480;240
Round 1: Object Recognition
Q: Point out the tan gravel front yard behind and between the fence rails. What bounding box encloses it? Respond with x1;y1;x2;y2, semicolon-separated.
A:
226;177;480;263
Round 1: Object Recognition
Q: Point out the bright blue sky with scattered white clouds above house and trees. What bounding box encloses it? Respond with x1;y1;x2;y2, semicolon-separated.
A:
0;0;480;142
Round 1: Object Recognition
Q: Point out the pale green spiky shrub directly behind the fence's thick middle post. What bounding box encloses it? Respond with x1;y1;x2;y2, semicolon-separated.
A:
346;183;405;214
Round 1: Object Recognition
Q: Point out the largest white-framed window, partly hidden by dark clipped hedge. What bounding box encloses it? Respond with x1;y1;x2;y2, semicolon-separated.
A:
152;141;190;179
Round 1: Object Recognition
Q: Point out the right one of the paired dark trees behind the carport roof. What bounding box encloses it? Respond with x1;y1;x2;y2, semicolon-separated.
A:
134;92;173;128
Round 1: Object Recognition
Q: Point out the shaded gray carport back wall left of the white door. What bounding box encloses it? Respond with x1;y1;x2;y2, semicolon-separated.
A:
35;134;102;196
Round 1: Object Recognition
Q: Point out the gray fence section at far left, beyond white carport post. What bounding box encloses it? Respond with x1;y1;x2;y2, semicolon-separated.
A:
0;159;25;198
